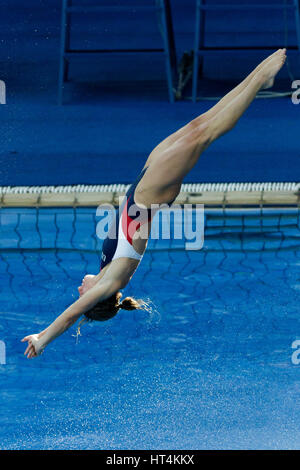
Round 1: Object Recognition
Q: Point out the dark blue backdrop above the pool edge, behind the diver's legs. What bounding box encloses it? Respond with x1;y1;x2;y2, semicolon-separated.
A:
0;0;300;186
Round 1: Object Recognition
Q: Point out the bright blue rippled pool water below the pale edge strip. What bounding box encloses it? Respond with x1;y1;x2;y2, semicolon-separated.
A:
0;209;300;449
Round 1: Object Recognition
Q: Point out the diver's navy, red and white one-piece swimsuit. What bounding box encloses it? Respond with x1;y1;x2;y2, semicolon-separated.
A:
100;168;155;270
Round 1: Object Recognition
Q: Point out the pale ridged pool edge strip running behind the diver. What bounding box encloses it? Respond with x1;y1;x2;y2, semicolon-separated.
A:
0;182;300;207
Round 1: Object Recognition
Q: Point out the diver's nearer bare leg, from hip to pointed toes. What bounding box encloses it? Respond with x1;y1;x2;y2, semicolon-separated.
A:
135;51;286;206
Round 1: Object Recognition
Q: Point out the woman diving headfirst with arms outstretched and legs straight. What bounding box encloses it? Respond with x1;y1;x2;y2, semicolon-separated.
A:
21;49;286;358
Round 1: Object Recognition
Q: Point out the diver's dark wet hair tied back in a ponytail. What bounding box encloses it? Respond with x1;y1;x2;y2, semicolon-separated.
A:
85;292;147;321
